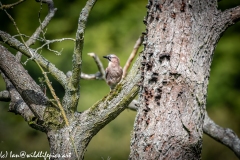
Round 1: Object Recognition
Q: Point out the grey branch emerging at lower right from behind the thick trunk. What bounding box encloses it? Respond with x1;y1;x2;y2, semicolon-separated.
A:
203;112;240;158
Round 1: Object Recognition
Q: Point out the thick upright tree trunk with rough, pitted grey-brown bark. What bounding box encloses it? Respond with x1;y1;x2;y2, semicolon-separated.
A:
129;0;221;159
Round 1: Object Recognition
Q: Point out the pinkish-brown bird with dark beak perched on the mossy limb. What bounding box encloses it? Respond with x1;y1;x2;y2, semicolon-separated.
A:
103;54;123;90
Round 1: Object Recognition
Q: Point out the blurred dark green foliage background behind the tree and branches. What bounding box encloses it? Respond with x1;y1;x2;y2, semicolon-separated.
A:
0;0;240;160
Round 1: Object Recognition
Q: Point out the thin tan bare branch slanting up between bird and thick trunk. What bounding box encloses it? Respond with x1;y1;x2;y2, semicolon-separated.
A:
122;35;143;78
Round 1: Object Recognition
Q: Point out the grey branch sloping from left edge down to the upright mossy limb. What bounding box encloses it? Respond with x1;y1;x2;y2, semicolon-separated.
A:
0;31;66;88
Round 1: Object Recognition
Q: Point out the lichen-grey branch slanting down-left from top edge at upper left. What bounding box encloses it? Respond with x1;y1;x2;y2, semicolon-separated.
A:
16;0;57;61
